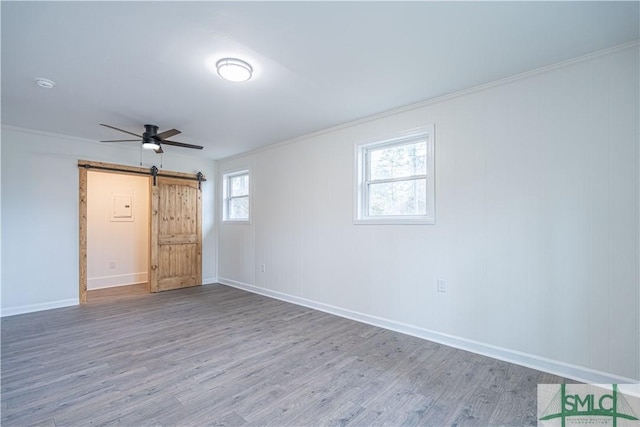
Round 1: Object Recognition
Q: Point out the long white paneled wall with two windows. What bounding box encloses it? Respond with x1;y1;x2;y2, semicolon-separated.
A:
219;45;640;382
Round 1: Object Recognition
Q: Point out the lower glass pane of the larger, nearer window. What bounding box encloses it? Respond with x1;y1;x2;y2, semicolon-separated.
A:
369;179;427;216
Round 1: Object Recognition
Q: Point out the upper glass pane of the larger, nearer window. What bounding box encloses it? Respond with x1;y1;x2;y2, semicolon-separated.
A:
369;141;427;181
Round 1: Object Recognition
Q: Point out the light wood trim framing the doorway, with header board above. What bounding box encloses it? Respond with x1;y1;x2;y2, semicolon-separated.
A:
78;160;207;304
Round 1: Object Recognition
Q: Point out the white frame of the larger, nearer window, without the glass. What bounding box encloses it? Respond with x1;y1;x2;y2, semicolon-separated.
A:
353;124;436;224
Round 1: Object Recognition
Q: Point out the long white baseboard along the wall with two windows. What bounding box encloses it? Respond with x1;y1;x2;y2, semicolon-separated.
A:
218;277;639;384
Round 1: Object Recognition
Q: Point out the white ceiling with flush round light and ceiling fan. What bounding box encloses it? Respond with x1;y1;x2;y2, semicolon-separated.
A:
0;1;640;159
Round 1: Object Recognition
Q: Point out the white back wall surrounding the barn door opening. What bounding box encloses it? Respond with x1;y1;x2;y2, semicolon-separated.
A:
1;127;217;316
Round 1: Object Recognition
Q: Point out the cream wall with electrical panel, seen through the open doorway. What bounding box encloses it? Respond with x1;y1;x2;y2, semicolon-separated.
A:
87;170;149;290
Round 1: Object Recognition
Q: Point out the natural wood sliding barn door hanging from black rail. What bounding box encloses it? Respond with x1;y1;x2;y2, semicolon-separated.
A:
149;176;202;292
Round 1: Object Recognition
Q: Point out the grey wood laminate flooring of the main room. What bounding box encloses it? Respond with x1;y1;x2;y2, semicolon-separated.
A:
1;285;566;426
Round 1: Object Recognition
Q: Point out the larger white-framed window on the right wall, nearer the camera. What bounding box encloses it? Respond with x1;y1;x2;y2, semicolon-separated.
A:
354;125;435;224
